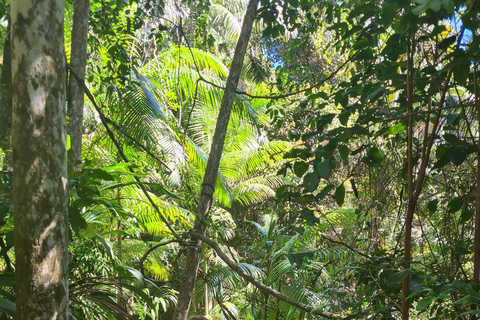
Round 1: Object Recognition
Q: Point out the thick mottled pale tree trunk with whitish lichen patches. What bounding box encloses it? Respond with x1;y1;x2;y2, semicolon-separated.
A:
11;0;68;320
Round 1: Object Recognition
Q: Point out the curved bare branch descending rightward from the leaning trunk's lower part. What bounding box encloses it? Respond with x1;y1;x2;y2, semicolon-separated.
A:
191;232;340;319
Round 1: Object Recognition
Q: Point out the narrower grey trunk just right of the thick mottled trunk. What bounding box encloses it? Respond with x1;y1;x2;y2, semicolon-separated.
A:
67;0;90;171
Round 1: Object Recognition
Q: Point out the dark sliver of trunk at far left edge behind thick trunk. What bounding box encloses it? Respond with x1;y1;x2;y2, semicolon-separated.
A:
0;22;12;167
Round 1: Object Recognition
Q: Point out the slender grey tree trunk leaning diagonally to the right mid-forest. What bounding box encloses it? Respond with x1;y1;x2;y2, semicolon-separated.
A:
174;0;258;320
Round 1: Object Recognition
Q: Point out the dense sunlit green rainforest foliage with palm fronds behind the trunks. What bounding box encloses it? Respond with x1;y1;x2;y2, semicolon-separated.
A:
4;0;480;320
